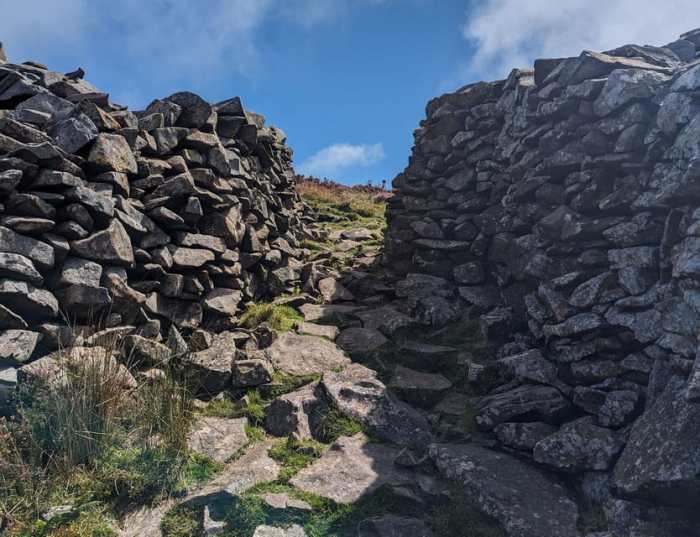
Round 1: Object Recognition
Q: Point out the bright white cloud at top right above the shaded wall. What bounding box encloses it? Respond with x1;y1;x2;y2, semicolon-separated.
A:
463;0;700;78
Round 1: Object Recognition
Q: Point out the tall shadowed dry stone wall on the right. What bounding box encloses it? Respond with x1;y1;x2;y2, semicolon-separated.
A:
386;31;700;535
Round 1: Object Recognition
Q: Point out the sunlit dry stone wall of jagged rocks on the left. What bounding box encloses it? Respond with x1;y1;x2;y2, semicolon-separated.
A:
0;48;302;395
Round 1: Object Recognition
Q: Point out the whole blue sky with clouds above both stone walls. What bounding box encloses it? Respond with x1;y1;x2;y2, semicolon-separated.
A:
0;0;700;183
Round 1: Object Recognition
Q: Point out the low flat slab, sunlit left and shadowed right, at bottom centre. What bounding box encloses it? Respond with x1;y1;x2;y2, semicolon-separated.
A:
290;434;413;504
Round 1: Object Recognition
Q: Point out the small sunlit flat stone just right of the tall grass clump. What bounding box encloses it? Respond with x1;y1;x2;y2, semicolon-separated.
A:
187;417;248;462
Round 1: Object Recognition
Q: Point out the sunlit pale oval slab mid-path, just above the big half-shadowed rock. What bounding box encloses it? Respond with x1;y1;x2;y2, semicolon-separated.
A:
264;332;350;375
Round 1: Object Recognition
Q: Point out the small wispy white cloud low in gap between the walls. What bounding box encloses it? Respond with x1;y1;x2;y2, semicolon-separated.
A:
298;144;384;176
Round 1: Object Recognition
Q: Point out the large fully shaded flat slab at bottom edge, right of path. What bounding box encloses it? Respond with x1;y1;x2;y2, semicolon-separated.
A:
429;444;580;537
